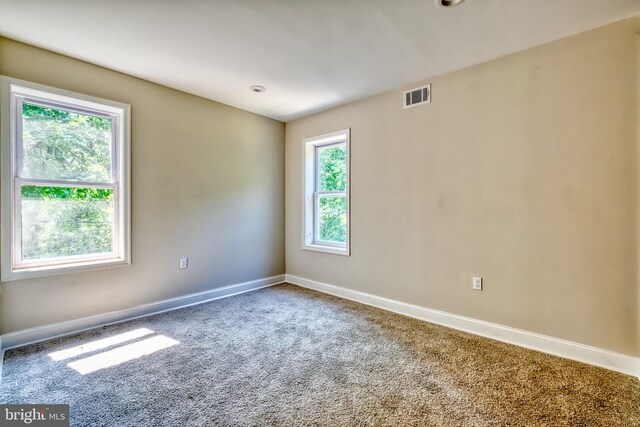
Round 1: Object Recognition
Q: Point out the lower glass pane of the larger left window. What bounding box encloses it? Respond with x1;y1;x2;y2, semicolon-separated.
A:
21;185;114;260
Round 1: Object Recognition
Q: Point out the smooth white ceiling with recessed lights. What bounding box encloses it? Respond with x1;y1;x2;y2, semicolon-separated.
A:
0;0;640;121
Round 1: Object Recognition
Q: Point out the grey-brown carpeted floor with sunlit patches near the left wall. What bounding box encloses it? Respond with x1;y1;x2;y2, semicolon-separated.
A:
0;285;640;427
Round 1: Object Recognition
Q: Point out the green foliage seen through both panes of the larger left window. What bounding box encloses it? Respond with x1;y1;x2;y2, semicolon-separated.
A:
21;103;114;259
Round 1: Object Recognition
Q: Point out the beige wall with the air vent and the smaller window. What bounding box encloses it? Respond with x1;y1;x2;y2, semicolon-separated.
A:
286;18;640;355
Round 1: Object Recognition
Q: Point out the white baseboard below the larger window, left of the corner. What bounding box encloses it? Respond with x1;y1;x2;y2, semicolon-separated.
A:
0;274;285;354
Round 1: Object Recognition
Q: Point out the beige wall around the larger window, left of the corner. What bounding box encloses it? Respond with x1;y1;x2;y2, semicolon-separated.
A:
0;38;284;333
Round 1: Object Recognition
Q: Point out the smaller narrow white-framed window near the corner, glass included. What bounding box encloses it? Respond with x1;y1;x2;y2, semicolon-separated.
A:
302;129;350;255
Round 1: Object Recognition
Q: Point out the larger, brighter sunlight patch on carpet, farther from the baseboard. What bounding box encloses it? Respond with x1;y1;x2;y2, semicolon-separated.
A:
67;335;180;375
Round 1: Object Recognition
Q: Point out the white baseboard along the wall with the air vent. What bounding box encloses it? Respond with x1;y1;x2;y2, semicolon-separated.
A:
286;274;640;377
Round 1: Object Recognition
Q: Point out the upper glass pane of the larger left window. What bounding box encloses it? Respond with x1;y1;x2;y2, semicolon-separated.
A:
22;103;111;182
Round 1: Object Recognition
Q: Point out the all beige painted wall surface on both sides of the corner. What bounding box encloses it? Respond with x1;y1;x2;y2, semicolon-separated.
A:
0;18;640;355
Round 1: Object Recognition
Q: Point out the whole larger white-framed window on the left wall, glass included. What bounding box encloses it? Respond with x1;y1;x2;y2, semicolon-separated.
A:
0;77;130;280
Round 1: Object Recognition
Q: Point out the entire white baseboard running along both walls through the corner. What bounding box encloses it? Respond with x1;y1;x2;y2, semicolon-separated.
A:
0;274;640;381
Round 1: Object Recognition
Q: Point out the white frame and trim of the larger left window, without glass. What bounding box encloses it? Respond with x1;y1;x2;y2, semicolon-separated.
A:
0;76;131;281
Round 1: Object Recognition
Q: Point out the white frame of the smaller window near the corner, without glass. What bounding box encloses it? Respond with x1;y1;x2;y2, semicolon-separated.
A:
302;129;351;256
